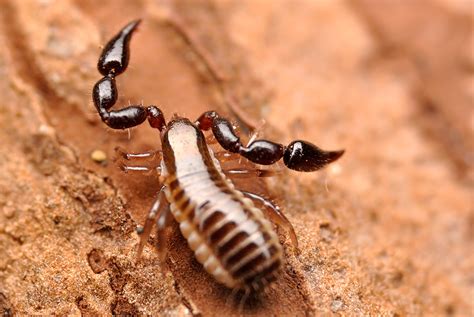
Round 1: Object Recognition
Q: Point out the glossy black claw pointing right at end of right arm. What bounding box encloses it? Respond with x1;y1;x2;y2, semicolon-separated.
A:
283;140;344;172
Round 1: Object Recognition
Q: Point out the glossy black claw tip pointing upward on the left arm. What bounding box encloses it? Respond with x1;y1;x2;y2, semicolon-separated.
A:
97;20;140;76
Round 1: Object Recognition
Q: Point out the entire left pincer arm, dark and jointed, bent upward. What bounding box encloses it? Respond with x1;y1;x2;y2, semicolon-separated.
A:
92;20;165;130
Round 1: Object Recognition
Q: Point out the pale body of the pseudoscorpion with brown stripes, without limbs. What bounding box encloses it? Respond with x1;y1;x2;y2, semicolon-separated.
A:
163;120;283;290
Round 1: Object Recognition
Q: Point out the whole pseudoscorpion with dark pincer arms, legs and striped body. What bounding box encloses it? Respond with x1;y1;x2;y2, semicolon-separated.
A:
93;21;343;293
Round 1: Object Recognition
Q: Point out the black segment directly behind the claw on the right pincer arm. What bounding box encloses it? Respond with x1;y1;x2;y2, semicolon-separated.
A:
239;140;284;165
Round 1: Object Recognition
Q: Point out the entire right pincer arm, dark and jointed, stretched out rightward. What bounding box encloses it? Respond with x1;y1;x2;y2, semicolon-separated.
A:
196;111;344;172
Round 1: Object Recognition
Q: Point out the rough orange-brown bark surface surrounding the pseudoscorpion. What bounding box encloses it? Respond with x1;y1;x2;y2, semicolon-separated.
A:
0;0;474;316
